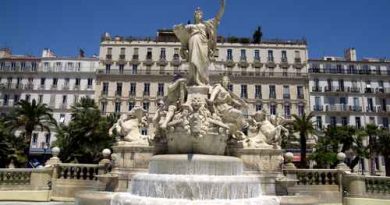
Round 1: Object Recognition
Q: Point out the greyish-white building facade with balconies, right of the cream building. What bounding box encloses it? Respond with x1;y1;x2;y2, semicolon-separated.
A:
309;49;390;175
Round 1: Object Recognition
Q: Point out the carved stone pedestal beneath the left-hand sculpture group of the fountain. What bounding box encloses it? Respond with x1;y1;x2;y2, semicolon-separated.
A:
112;144;154;191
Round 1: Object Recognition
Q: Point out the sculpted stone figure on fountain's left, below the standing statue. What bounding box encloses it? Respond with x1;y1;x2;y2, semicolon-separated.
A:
160;74;187;130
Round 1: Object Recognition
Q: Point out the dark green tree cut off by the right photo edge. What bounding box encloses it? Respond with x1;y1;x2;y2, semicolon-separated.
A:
375;130;390;176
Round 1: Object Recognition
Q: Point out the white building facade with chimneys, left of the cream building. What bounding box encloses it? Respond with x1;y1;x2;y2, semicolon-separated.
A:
0;50;98;155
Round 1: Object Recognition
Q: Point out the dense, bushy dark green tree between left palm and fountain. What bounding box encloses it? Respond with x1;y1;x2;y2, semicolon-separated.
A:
54;98;115;163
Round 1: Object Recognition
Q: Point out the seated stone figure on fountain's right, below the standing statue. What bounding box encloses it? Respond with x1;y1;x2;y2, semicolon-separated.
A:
209;76;247;137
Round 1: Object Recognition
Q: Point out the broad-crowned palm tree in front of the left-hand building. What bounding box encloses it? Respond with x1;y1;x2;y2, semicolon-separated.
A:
6;99;57;155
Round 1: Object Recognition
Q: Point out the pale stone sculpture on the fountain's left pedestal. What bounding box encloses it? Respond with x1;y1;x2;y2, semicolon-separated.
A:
109;106;149;146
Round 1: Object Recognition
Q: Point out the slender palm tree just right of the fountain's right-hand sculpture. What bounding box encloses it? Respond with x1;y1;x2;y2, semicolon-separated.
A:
292;112;315;168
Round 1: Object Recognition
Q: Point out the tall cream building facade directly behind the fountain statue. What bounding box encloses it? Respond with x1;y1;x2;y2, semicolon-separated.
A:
95;32;309;133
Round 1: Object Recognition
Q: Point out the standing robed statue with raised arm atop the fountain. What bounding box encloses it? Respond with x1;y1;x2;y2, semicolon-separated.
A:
173;0;225;85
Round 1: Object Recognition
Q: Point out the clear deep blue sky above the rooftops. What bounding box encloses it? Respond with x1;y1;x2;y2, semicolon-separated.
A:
0;0;390;58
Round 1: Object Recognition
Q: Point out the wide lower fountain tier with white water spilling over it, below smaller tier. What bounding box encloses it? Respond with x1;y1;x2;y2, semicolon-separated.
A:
131;174;261;200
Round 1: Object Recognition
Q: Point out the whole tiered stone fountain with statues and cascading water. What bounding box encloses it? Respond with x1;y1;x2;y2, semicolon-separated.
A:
76;0;316;205
